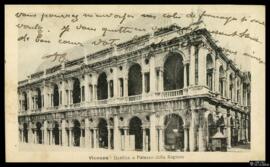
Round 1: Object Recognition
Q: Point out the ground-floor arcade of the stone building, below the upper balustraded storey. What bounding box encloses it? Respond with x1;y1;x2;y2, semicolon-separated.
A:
19;100;250;151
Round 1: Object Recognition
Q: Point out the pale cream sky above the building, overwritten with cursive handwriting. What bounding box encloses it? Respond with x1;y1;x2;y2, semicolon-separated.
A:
16;6;265;80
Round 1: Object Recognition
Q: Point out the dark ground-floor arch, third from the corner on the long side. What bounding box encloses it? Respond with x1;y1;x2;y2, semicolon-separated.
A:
98;118;108;148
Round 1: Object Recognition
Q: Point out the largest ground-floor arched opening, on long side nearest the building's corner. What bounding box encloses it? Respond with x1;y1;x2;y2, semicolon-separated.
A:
164;114;184;151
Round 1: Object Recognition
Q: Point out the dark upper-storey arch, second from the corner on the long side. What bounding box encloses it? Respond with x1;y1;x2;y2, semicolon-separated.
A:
128;64;142;96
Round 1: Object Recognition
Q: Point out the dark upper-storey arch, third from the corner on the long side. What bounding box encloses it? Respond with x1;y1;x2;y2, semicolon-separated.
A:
97;72;108;100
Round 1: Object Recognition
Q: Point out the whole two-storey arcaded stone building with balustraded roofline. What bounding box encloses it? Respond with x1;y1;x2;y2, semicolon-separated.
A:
18;25;251;151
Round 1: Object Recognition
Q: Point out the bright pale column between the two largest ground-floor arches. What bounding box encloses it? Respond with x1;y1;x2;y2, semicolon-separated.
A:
150;114;158;151
